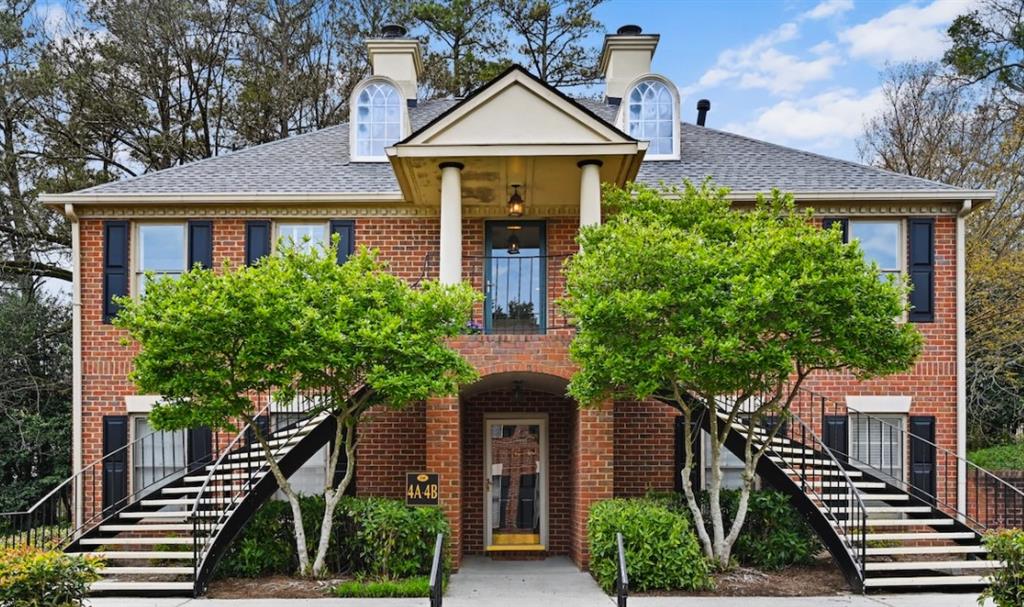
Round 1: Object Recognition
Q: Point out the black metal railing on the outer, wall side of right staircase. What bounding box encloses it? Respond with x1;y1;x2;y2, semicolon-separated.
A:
806;390;1024;533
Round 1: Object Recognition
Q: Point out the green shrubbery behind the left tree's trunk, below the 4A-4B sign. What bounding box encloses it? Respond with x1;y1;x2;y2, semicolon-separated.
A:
217;495;451;579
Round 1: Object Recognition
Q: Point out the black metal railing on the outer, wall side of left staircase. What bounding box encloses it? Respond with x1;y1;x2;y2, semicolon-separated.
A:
0;411;222;550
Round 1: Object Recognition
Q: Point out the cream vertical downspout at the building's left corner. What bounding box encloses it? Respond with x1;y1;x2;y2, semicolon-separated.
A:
65;205;85;528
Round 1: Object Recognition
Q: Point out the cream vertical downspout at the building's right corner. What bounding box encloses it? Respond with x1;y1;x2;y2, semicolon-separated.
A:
956;200;974;512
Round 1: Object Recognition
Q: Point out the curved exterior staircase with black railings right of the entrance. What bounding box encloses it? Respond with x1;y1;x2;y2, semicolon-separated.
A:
701;393;1024;592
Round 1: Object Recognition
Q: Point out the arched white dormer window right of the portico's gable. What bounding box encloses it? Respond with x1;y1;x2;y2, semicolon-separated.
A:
623;77;679;160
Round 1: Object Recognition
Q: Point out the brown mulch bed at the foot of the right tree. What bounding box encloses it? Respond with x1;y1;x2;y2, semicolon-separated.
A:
638;560;850;597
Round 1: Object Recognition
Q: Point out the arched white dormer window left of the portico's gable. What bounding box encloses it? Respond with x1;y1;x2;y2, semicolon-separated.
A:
351;78;408;161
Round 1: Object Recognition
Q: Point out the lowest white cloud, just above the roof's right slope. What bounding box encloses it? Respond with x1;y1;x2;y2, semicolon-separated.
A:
725;88;883;150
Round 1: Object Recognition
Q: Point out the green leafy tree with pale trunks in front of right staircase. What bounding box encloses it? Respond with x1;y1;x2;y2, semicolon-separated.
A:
563;183;922;568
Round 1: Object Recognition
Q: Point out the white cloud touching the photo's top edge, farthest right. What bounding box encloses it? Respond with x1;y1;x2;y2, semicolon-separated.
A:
839;0;973;63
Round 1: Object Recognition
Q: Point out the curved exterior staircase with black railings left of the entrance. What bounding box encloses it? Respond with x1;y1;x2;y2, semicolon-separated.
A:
0;393;335;597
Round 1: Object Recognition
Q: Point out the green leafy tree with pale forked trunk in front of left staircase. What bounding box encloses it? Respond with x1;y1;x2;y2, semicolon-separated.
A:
116;240;476;576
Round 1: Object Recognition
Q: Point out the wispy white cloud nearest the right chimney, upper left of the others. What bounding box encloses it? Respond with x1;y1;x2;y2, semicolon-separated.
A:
696;23;841;95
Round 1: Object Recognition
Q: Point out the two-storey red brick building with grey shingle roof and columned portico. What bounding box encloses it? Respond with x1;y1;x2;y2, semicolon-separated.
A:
45;28;991;593
